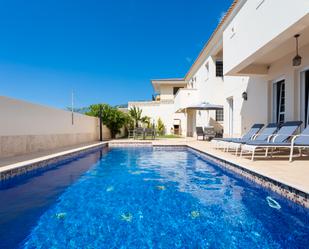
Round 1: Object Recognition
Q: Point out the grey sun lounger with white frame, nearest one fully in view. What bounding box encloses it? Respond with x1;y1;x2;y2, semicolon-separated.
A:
240;121;307;161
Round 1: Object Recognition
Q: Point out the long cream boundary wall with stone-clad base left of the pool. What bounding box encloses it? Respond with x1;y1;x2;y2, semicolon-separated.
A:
0;96;110;158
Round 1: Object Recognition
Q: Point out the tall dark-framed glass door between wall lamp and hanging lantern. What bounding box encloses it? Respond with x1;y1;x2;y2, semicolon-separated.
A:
273;80;285;124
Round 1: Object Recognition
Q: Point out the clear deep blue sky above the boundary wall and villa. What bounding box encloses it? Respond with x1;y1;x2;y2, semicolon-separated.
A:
0;0;232;108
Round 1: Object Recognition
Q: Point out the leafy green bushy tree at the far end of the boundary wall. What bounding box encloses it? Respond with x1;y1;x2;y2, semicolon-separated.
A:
86;104;130;138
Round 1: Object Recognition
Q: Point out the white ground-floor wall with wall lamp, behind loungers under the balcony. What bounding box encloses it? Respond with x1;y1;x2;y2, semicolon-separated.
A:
224;44;309;137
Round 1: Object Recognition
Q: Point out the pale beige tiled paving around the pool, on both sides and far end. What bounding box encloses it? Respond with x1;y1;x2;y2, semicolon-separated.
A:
0;138;309;194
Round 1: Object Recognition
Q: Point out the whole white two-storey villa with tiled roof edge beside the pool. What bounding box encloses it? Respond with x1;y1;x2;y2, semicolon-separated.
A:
128;0;309;137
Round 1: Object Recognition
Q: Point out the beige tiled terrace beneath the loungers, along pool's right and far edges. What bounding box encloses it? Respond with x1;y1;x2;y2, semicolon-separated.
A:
111;138;309;193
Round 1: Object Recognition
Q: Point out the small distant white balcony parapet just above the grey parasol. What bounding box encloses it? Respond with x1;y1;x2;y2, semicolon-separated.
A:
174;88;198;112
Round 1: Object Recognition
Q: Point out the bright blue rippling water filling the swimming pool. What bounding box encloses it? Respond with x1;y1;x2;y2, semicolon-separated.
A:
0;148;309;249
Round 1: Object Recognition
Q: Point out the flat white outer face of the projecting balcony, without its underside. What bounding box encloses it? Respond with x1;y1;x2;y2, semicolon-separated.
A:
223;0;309;73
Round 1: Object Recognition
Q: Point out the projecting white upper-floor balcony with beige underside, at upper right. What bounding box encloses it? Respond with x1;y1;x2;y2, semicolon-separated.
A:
223;0;309;76
